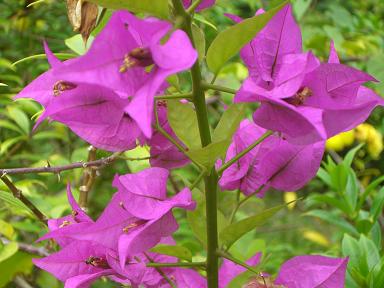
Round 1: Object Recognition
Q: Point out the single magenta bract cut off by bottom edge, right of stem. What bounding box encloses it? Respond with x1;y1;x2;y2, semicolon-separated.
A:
275;256;348;288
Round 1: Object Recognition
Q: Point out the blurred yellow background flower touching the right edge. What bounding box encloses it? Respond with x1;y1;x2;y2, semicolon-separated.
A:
355;123;384;159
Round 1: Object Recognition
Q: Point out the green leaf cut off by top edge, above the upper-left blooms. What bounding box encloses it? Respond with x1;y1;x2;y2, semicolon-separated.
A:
90;0;169;19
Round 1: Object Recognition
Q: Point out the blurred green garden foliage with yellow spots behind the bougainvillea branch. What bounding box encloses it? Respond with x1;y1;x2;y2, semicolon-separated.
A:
0;0;384;288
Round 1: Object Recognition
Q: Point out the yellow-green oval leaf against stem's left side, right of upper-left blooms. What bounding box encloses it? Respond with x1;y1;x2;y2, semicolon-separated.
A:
167;100;201;149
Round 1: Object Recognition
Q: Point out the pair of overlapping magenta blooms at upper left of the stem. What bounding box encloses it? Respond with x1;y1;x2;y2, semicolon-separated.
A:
15;11;197;151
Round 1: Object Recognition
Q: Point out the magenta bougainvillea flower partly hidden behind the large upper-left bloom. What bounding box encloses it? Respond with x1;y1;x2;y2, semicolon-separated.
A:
15;43;145;151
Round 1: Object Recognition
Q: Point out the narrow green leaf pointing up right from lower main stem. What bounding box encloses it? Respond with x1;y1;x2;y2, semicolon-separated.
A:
219;204;287;248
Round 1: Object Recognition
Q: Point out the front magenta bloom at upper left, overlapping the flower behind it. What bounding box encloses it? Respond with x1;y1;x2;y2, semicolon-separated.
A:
56;11;197;138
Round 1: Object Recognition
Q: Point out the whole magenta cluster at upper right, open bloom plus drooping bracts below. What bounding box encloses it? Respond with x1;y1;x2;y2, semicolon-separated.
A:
220;5;384;196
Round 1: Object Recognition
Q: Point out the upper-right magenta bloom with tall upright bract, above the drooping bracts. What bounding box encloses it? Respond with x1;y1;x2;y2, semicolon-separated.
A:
232;5;384;144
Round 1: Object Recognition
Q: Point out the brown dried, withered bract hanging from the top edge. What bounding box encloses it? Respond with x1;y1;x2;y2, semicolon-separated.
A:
67;0;99;42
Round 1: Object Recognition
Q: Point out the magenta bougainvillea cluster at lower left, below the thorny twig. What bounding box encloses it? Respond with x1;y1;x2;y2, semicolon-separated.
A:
34;168;195;288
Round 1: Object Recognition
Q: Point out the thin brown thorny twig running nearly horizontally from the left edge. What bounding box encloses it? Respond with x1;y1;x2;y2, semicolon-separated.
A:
0;152;122;175
